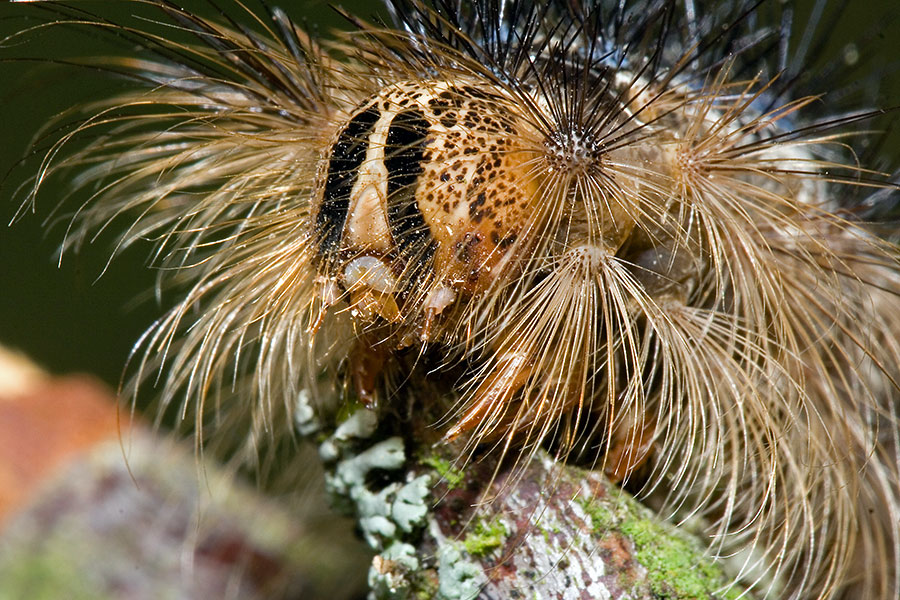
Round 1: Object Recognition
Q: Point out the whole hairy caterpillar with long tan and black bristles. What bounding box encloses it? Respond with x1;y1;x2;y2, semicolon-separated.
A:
5;0;900;598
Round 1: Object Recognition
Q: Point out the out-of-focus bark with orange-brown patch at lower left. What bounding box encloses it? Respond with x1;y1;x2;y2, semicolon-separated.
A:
0;347;371;600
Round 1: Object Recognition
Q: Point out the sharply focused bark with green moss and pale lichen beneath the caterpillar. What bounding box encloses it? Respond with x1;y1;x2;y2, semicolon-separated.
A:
312;409;747;600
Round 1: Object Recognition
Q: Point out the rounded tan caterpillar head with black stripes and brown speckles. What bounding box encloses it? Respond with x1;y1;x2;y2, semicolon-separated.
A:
312;81;541;340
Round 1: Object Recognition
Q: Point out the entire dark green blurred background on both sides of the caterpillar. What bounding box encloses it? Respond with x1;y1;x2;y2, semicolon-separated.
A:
0;0;900;386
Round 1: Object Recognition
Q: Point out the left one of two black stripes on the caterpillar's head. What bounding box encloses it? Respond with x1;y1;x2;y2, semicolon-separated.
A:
316;106;381;255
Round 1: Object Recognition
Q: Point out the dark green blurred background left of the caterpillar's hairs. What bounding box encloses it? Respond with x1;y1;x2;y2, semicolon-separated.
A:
0;0;377;386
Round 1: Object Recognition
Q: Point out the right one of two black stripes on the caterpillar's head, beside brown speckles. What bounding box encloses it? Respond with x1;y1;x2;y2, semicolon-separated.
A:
384;110;434;266
